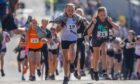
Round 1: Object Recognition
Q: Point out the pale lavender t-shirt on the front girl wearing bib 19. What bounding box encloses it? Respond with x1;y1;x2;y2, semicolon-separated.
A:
55;14;81;41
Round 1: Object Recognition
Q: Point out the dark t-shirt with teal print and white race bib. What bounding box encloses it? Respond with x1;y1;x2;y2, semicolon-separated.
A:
92;17;112;40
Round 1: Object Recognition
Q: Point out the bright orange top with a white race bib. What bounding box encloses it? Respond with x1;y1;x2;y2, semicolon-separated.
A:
26;28;43;49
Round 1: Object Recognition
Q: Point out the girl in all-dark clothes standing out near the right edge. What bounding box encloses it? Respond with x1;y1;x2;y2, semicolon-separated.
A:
123;30;135;80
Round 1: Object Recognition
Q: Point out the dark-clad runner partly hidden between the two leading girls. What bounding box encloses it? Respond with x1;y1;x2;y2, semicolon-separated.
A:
74;8;88;79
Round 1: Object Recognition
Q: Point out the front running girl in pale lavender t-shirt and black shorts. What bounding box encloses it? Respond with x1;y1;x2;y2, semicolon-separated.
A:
55;3;81;84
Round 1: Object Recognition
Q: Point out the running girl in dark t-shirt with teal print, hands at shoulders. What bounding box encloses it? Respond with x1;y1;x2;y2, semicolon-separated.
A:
88;7;119;80
